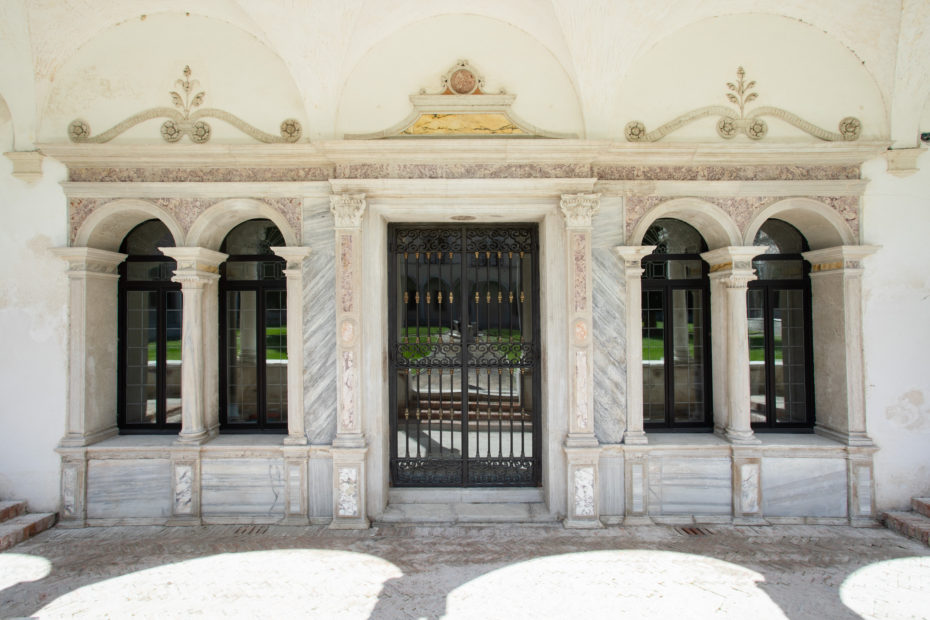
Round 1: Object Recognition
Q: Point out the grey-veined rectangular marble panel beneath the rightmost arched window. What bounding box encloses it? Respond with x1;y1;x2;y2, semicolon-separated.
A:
762;458;847;517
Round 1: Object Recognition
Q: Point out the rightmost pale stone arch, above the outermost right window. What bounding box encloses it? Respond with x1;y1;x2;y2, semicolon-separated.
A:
743;198;856;250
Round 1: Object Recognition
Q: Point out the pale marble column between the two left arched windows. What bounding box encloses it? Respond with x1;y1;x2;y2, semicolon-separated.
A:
159;247;226;444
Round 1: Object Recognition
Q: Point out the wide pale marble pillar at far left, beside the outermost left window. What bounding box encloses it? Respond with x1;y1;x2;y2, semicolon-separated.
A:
52;247;126;447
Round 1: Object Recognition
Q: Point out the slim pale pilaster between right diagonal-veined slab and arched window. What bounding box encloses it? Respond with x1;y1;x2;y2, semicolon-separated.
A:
614;245;656;444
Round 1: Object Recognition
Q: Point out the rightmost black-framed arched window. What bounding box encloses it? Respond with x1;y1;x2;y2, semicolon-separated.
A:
746;219;814;430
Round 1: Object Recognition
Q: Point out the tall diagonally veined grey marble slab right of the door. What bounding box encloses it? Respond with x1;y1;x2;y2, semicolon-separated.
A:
591;247;626;443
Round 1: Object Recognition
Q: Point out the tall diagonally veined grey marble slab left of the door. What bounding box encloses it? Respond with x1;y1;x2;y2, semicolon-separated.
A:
303;202;337;446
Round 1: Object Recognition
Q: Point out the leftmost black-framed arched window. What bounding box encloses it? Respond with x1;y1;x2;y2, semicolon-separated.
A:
117;220;182;432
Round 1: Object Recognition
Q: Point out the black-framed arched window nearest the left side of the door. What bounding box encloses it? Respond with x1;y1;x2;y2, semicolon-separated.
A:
220;220;287;432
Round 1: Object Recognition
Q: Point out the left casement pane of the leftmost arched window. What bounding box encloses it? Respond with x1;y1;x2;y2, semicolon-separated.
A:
125;291;158;424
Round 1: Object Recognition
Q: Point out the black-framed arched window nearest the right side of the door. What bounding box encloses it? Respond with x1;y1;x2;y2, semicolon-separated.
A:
642;219;711;430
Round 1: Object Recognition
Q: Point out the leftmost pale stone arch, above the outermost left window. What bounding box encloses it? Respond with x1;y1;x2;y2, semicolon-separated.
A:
74;198;185;252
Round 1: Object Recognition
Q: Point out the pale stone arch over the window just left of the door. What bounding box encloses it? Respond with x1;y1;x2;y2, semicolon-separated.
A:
187;198;297;250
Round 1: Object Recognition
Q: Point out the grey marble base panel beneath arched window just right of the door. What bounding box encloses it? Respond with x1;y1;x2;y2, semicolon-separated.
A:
649;456;733;515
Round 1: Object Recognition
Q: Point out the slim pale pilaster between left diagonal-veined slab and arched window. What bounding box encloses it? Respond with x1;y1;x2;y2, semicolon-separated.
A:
271;247;310;446
